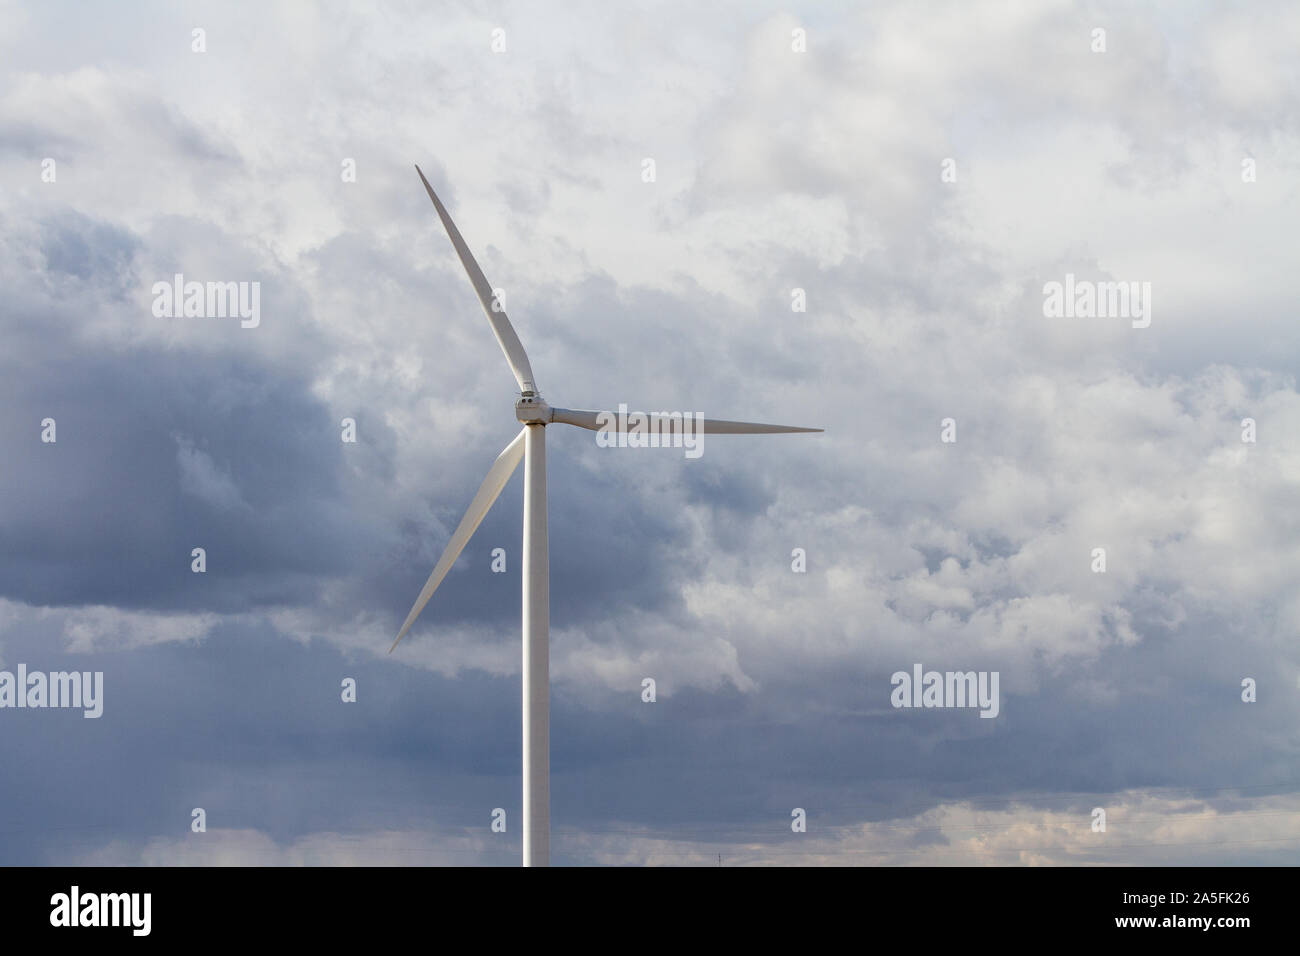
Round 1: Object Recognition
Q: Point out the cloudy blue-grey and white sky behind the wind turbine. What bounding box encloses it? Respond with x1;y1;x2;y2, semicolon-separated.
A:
0;0;1300;865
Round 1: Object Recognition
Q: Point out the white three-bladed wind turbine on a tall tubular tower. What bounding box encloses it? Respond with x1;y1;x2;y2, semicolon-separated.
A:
389;165;822;866
